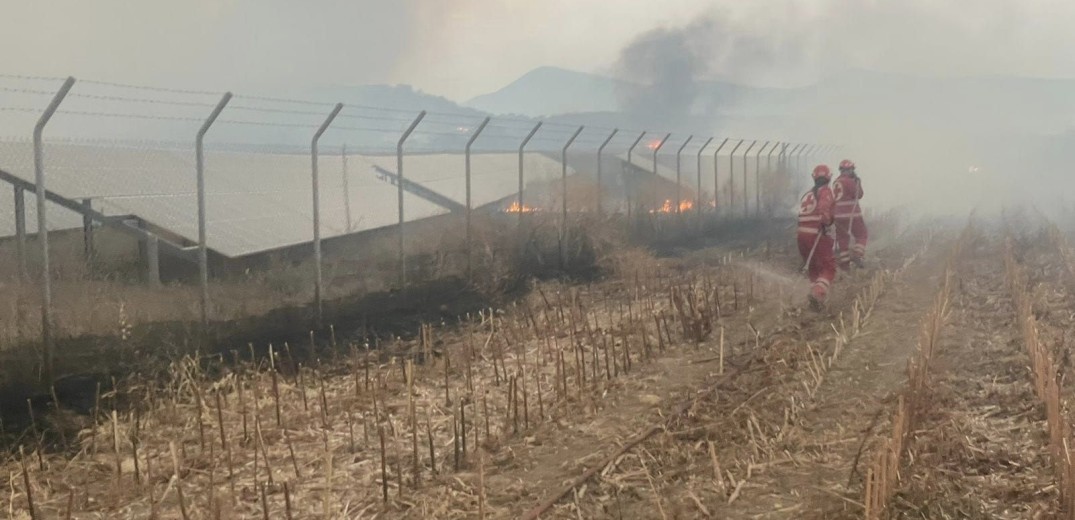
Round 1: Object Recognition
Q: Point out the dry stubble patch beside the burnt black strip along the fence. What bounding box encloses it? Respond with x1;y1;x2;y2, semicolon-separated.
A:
0;225;774;518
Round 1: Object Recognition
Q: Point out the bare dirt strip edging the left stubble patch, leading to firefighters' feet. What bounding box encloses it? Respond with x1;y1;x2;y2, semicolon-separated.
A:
486;250;862;518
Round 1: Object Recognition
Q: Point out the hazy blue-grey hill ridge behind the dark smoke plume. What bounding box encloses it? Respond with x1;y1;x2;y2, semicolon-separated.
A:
463;67;1075;139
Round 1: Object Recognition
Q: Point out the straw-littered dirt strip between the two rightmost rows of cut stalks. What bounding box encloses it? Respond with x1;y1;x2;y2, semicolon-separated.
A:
893;239;1058;518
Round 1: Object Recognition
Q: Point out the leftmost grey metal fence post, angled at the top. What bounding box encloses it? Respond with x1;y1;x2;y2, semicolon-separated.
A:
33;76;74;385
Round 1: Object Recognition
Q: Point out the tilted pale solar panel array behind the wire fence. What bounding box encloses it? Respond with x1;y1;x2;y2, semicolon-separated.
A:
0;141;573;257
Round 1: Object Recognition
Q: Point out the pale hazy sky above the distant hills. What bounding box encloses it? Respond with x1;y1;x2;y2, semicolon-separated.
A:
0;0;1075;100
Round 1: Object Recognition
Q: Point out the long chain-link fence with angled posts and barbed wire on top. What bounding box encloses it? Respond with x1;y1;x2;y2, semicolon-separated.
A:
0;71;835;378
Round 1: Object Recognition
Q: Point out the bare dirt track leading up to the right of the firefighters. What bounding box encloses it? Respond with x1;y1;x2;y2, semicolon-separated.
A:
712;232;947;519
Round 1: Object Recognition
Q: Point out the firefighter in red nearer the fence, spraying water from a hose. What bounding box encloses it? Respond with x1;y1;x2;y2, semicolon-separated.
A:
798;164;836;310
